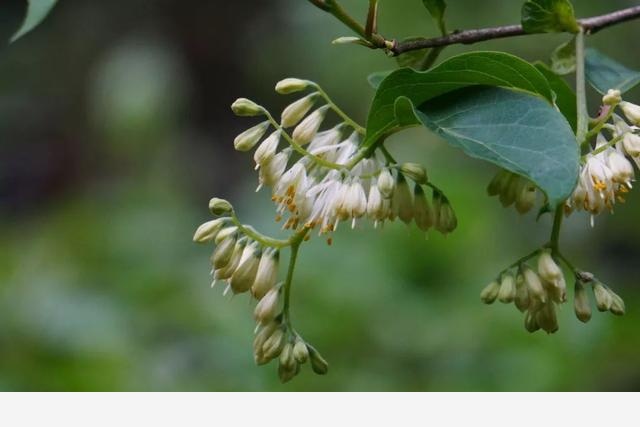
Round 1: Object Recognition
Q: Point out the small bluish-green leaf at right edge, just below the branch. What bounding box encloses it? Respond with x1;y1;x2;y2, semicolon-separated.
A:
585;49;640;94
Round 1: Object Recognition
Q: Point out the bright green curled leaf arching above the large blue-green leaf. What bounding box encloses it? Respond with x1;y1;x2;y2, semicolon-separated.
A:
363;52;554;146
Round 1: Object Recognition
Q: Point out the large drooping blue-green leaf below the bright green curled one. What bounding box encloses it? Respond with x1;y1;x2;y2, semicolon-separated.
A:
417;86;580;206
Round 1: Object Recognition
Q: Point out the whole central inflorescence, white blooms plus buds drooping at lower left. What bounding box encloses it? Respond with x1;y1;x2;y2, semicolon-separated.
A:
194;78;457;382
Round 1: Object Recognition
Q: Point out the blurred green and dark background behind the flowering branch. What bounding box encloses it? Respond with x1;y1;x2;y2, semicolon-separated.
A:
0;0;640;391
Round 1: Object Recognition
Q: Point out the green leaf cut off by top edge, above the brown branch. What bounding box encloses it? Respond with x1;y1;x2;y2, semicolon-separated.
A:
522;0;580;33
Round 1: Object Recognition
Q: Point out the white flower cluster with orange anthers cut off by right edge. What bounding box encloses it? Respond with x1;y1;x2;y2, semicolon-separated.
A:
565;90;640;225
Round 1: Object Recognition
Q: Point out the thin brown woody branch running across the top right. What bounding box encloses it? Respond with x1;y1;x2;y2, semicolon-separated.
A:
390;6;640;55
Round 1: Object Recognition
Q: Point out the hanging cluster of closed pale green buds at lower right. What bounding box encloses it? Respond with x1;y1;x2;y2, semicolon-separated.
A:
480;250;624;334
